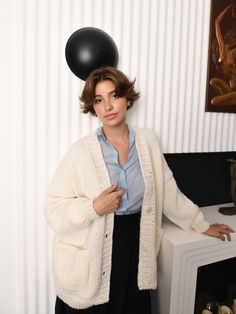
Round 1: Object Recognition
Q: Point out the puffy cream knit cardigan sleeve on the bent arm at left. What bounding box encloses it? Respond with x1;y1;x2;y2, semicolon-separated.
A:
45;142;100;234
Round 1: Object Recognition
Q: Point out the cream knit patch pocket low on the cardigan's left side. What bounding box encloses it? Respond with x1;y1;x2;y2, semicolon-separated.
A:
53;240;89;291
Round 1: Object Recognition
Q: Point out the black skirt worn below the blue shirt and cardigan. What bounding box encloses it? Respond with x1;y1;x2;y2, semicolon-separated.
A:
55;213;151;314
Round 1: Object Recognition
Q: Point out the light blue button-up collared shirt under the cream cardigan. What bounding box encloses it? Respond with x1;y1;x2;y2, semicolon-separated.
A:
97;128;145;215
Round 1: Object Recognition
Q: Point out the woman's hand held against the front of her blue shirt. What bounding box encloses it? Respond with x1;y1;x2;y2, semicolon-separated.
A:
93;184;124;216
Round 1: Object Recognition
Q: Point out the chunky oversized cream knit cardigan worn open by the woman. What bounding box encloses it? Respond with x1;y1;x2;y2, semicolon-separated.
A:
46;129;209;309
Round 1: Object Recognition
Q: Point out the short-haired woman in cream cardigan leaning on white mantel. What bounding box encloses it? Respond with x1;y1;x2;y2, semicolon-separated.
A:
46;67;233;314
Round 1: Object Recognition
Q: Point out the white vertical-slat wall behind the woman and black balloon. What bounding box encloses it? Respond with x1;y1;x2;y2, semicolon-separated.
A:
13;0;236;314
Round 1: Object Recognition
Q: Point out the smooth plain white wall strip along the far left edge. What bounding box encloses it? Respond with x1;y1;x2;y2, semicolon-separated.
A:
0;1;17;314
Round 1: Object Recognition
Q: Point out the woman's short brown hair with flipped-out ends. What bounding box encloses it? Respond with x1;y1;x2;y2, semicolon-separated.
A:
80;67;140;116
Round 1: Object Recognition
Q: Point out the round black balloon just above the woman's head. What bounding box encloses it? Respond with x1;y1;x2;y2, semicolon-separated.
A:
65;27;118;80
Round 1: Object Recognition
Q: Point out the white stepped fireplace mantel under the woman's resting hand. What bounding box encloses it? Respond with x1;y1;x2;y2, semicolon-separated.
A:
153;204;236;314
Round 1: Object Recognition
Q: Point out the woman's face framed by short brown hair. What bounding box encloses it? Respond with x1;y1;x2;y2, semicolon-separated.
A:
93;80;128;127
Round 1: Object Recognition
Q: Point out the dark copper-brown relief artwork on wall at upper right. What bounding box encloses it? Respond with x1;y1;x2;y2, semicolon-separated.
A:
205;0;236;113
